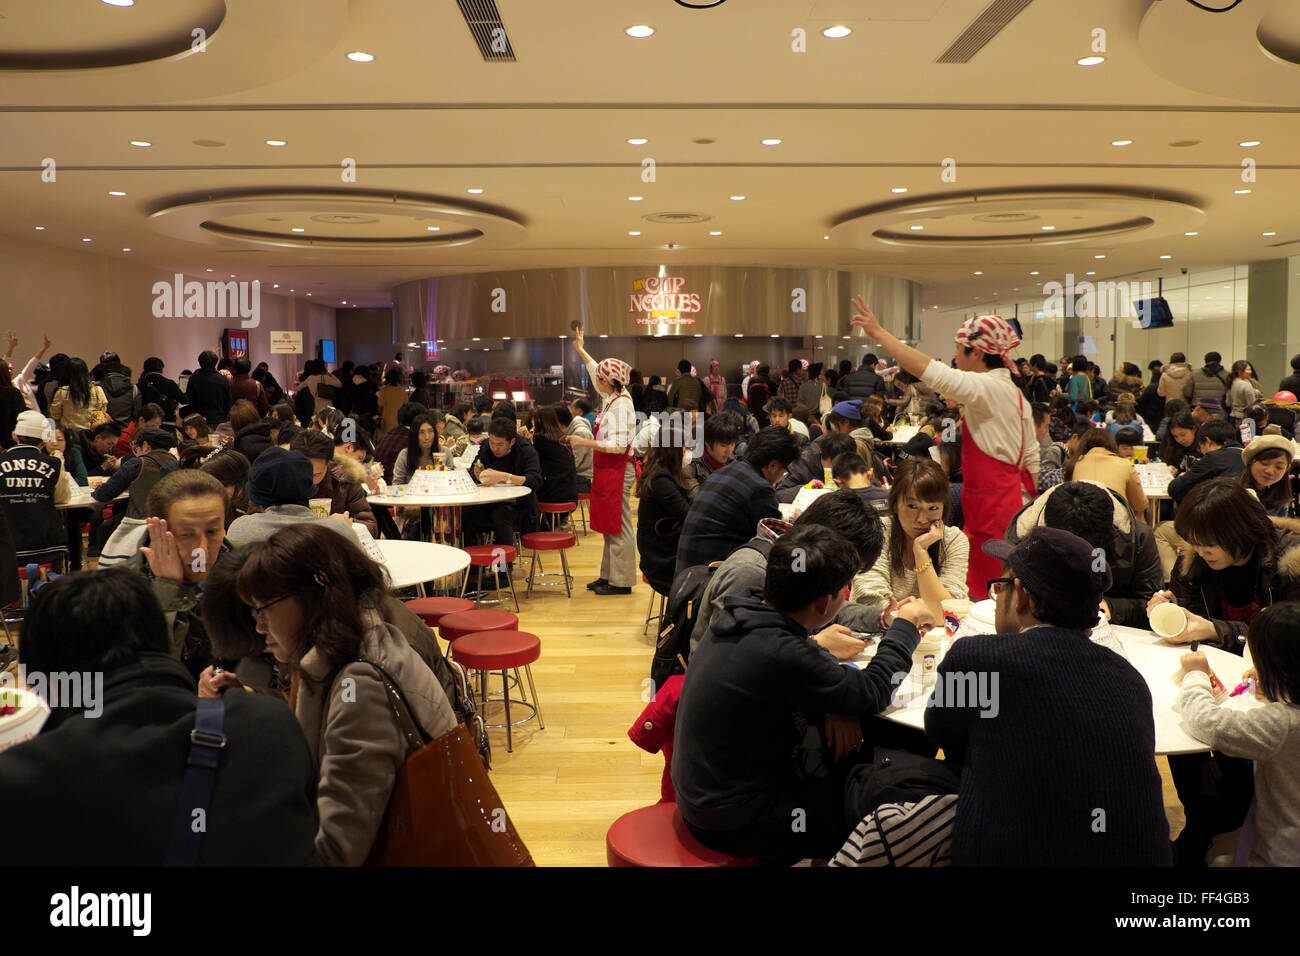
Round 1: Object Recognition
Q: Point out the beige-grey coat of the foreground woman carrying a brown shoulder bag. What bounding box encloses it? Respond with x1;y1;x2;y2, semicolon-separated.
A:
294;610;456;866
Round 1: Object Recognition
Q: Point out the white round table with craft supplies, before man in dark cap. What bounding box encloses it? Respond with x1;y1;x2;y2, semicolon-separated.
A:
850;601;1261;756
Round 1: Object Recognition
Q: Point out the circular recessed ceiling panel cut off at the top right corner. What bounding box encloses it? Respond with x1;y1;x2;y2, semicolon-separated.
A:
1138;0;1300;105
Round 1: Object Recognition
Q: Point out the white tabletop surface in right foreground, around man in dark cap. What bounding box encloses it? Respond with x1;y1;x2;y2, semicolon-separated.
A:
858;601;1262;756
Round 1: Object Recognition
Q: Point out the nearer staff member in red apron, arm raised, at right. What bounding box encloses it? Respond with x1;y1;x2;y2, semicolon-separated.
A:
853;295;1039;601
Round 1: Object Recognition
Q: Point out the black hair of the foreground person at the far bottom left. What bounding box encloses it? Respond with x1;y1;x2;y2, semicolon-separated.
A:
18;568;172;681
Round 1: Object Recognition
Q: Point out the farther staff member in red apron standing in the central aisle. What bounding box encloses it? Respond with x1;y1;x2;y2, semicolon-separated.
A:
564;328;637;594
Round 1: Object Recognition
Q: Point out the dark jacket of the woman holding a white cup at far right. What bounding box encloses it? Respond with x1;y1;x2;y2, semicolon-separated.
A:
1173;518;1300;654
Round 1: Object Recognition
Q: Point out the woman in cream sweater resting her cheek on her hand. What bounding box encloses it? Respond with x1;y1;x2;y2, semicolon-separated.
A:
853;458;970;626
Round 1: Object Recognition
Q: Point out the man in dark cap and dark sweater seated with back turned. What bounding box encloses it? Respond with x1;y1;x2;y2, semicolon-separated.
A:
926;527;1171;866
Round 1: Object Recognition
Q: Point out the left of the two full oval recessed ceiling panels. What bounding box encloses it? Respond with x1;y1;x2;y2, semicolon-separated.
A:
150;191;528;250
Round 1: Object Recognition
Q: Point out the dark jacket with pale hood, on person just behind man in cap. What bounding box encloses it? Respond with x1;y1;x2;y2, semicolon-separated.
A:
1004;481;1165;628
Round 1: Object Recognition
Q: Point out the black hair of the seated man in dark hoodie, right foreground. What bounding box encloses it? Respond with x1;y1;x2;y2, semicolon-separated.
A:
759;522;863;614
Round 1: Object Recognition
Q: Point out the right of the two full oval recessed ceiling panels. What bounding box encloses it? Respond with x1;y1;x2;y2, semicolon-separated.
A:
832;190;1205;248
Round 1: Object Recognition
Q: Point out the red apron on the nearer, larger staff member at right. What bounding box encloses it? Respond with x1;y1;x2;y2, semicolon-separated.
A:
962;395;1037;601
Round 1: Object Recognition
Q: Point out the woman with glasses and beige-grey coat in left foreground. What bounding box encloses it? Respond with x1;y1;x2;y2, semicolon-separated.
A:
208;522;456;866
